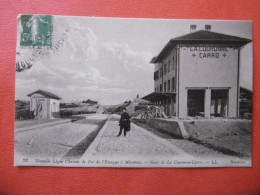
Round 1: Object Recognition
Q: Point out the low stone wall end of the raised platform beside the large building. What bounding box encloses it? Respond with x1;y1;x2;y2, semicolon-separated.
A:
146;119;184;138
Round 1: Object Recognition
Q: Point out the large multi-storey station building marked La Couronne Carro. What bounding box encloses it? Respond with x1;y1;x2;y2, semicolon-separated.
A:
143;25;251;118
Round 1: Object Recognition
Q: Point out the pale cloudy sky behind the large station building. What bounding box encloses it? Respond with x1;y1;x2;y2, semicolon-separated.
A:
16;16;253;105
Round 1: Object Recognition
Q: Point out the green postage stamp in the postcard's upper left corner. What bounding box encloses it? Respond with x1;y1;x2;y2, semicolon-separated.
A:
20;15;52;47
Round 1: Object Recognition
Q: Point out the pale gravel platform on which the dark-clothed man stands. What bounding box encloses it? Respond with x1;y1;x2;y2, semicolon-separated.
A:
84;115;191;158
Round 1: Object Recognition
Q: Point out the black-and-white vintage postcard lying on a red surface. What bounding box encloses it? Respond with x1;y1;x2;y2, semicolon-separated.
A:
14;15;253;168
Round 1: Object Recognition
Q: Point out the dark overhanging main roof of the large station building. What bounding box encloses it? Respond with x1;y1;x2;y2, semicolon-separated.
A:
151;30;251;63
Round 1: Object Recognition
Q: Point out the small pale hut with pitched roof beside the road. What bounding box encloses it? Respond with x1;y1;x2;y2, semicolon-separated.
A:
27;90;61;119
